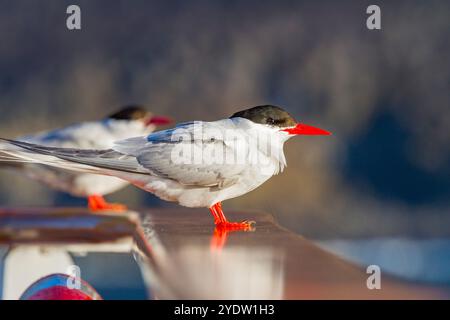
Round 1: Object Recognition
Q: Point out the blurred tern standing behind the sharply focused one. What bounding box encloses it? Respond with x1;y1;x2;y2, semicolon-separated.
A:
0;106;170;210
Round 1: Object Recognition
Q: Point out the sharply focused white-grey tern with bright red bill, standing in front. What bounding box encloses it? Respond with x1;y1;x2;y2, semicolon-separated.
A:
0;106;330;229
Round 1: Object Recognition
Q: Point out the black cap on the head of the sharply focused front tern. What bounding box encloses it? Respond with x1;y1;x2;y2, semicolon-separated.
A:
230;105;297;128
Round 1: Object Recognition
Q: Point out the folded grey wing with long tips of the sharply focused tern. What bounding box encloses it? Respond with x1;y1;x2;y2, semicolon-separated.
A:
2;139;245;188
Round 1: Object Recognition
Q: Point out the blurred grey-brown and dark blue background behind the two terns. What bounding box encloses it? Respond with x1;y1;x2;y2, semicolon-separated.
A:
0;0;450;252
